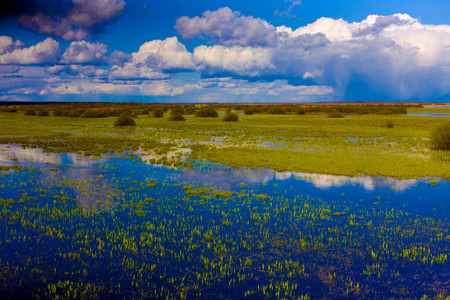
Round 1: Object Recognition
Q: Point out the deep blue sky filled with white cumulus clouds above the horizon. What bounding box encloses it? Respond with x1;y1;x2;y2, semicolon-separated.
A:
0;0;450;103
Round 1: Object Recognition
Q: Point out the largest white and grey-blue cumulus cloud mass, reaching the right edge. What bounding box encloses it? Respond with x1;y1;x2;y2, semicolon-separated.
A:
176;8;450;99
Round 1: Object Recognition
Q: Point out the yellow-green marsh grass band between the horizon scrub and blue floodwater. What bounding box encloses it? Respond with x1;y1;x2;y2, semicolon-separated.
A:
0;112;450;178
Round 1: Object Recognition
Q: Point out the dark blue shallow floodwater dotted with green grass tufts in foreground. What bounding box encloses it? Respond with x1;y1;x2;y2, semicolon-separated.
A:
0;145;450;299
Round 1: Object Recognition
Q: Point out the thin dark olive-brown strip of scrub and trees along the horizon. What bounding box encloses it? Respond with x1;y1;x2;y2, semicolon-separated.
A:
0;102;423;118
